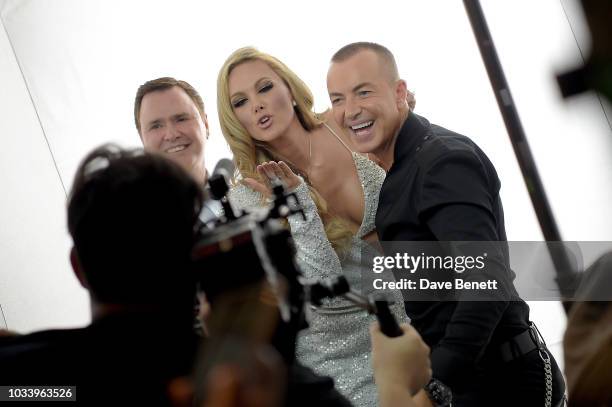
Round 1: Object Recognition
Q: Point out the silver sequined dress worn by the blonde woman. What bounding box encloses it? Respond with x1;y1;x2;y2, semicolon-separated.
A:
229;152;408;407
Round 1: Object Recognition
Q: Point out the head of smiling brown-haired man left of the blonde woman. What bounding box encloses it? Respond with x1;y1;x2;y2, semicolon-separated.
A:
134;77;209;185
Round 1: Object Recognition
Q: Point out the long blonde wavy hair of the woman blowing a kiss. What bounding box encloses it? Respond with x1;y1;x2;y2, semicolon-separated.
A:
217;47;354;253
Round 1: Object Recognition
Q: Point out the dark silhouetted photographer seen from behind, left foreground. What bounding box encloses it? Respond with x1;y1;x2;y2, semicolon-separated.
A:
0;146;202;406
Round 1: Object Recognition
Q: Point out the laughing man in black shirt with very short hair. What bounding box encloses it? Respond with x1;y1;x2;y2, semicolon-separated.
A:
327;43;564;406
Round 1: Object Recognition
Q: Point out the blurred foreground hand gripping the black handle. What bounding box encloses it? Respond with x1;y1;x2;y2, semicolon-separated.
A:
370;323;432;397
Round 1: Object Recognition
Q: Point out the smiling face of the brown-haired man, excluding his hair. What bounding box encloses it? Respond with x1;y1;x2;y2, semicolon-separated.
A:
140;86;208;177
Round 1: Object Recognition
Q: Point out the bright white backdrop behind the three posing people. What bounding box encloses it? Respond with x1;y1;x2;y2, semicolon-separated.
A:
0;0;612;366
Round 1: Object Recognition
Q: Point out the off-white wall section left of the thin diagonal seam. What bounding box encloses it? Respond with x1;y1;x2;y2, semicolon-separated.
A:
0;4;88;331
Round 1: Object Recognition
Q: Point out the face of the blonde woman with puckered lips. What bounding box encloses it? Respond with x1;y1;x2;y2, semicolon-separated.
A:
228;60;297;142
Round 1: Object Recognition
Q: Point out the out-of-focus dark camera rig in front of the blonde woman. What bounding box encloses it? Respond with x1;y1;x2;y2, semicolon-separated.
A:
192;175;307;361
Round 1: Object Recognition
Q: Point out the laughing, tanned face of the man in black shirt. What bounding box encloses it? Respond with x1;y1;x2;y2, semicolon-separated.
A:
327;50;406;155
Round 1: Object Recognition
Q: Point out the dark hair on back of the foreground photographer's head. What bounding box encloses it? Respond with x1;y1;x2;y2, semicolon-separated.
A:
68;144;203;304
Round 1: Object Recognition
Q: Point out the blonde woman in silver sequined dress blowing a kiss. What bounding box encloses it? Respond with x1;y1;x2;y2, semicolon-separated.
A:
217;47;407;406
